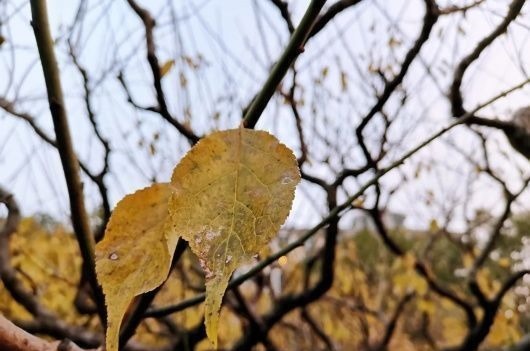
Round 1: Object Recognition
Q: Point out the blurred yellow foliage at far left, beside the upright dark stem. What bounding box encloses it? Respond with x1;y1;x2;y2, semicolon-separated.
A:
0;218;93;325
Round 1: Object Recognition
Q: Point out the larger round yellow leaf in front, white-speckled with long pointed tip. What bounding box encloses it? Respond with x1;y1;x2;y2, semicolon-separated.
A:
169;128;300;347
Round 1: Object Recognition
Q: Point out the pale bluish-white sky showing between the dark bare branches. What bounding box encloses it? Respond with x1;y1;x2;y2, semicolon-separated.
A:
0;0;530;235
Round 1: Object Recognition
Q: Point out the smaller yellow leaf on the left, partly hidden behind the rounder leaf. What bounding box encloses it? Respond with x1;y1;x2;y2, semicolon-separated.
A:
96;184;177;351
